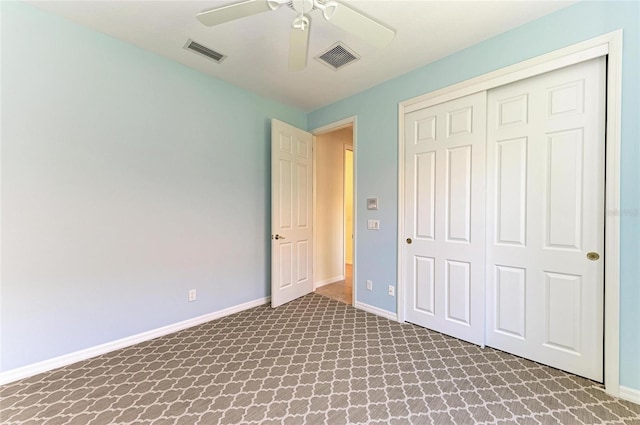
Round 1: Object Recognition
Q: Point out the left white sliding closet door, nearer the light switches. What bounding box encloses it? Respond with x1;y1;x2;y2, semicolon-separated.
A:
403;92;486;345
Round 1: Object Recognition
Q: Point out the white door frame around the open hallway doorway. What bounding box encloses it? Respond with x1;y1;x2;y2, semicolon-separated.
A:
309;115;358;306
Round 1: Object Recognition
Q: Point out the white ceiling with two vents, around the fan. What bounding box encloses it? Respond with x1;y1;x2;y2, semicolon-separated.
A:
29;0;574;111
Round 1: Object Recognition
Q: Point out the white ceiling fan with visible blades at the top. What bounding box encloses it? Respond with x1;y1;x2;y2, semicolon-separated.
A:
197;0;395;71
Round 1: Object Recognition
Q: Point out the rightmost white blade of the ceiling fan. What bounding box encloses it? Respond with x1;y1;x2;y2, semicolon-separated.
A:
329;3;396;48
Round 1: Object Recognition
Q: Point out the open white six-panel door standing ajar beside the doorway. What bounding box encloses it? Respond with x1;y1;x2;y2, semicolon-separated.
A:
271;119;313;307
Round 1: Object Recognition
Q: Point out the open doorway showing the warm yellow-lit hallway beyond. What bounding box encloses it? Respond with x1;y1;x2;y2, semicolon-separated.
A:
314;122;354;305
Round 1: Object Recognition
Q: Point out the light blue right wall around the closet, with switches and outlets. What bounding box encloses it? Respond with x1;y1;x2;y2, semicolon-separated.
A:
308;1;640;389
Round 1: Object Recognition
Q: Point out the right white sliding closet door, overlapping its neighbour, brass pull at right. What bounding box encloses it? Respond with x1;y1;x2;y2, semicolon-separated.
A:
486;58;605;382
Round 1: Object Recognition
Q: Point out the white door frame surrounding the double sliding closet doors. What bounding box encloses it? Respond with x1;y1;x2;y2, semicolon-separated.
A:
396;30;622;397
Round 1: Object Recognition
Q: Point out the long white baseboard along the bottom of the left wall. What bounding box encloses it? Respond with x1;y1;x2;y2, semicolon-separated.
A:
0;297;271;385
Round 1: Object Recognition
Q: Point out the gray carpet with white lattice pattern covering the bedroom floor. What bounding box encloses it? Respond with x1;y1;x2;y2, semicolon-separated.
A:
0;294;640;425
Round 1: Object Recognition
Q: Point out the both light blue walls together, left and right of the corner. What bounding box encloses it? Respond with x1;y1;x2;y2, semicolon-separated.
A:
0;2;640;389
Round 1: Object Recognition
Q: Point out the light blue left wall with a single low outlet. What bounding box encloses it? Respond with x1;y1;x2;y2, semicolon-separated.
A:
0;2;307;371
